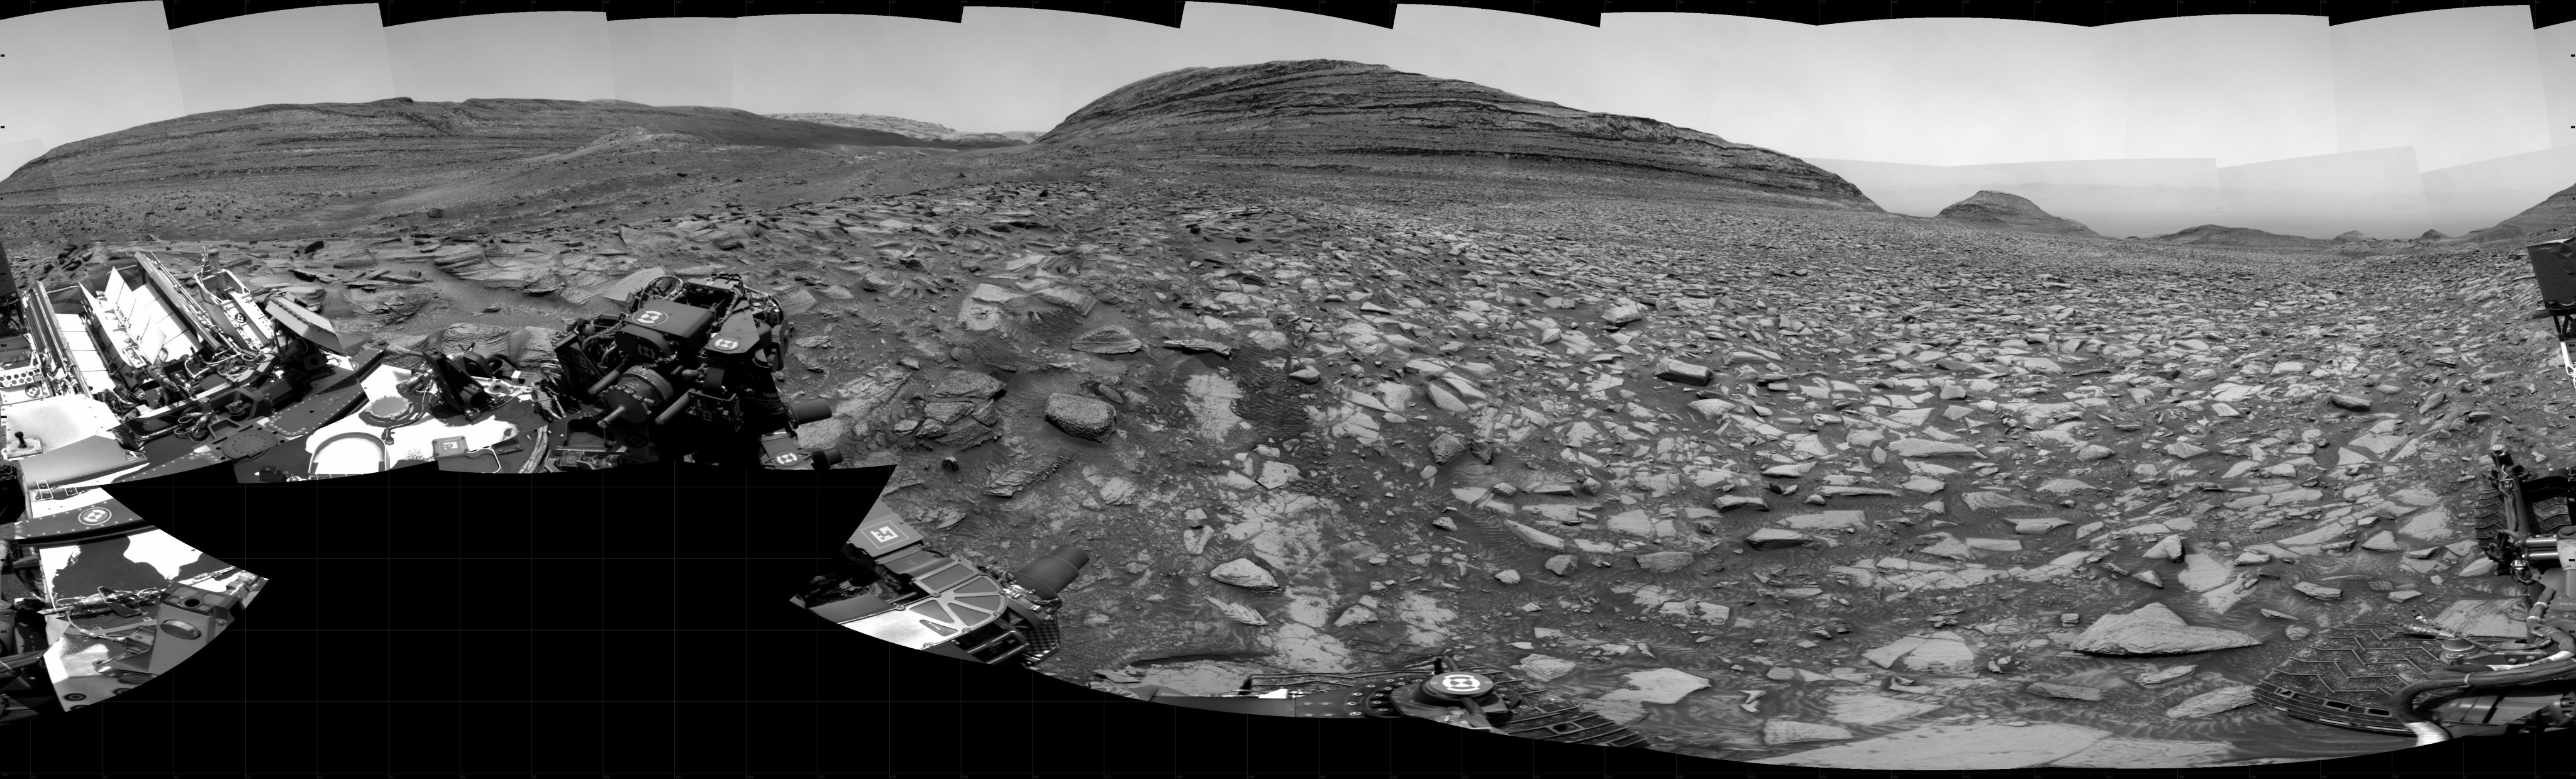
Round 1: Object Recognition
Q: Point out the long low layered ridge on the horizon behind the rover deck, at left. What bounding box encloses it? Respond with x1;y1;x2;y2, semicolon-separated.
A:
0;98;971;194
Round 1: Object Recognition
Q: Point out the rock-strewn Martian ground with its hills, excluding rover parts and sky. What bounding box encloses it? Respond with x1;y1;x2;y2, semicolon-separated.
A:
0;62;2576;769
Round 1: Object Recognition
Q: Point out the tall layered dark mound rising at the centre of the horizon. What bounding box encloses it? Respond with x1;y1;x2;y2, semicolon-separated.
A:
1038;59;1878;211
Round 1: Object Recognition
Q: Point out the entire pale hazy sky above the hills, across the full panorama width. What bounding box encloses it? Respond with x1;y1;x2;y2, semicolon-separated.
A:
0;3;2576;232
